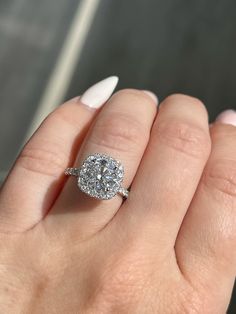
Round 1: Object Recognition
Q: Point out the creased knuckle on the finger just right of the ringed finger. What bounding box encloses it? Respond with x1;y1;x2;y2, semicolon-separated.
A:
154;121;210;158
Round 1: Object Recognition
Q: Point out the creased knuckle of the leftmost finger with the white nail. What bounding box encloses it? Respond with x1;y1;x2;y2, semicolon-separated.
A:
17;143;68;177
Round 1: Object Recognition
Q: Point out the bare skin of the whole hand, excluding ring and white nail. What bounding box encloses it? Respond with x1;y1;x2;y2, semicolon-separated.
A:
0;89;236;314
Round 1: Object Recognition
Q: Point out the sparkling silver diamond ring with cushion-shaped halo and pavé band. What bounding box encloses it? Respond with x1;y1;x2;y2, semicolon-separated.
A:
65;153;129;200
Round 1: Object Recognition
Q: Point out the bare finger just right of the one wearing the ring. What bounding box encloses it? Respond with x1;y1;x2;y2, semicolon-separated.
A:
114;95;210;248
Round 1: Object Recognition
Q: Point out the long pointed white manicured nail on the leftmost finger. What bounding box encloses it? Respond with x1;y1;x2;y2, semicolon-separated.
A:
80;76;119;109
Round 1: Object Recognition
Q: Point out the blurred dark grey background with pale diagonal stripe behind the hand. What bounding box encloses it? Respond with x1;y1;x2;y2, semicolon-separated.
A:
0;0;236;313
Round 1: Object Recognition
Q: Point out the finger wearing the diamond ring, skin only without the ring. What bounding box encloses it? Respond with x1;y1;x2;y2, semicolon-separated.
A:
47;89;157;236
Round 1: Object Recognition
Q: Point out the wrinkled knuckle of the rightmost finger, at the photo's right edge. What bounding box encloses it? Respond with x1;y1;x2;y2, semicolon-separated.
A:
203;159;236;199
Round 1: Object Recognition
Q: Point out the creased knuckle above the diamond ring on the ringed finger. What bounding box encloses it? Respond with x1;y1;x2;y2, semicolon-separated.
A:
90;114;146;152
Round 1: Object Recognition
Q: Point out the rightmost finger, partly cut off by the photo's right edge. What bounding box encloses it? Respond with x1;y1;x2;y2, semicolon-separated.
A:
176;114;236;312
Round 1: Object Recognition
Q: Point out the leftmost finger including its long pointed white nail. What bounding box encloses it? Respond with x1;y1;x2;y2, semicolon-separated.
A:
0;77;117;232
